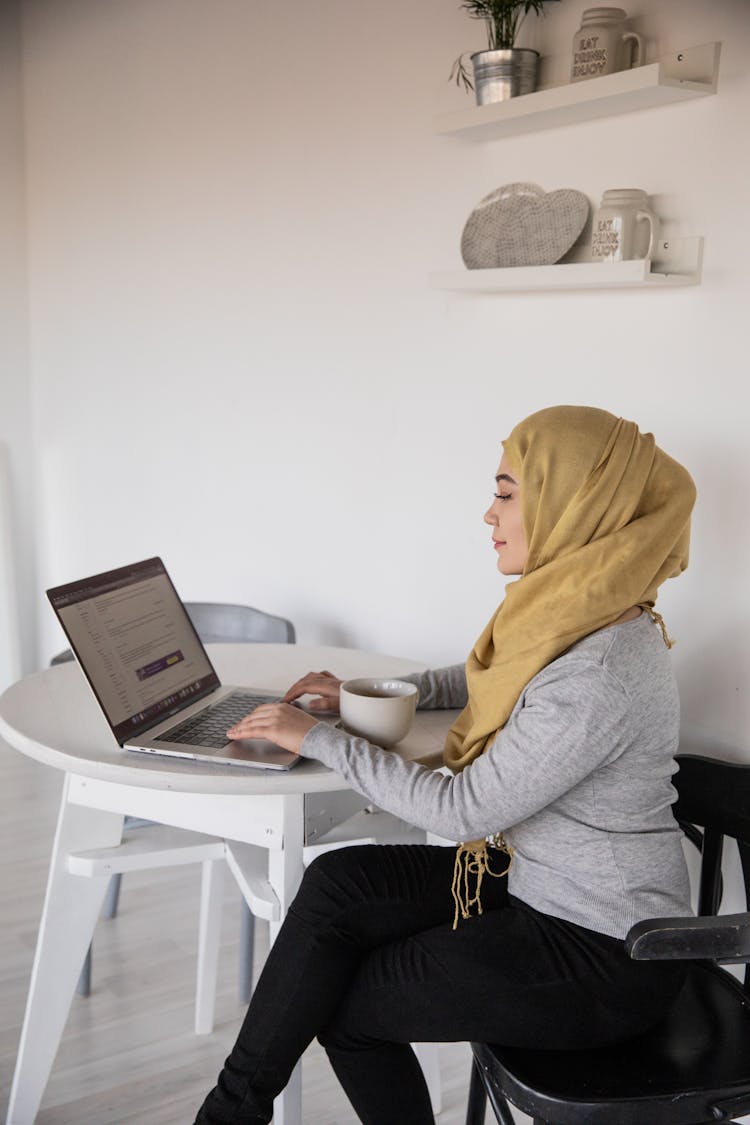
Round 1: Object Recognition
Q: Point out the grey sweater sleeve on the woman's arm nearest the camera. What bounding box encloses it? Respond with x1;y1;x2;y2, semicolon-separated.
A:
300;664;629;840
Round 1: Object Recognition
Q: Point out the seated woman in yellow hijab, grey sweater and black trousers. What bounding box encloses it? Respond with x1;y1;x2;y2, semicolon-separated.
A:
197;406;695;1125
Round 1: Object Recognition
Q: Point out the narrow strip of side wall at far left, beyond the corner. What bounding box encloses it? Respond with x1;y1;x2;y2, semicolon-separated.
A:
0;0;36;691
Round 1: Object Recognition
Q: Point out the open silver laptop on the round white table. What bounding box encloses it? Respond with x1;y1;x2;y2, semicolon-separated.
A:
47;558;299;770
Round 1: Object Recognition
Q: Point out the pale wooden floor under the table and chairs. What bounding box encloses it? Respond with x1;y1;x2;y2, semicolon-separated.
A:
0;741;527;1125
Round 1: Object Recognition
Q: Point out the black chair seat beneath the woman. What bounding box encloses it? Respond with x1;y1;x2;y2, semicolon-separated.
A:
472;962;750;1125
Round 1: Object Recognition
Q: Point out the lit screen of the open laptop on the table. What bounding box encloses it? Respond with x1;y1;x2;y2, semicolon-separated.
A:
47;558;219;745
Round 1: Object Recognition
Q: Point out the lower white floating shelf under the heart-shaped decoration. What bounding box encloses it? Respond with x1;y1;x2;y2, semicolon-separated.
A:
431;237;703;294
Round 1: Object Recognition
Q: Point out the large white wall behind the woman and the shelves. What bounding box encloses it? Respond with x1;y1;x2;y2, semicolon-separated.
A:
14;0;750;756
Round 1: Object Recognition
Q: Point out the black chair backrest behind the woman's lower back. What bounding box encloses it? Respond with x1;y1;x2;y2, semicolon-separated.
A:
675;754;750;990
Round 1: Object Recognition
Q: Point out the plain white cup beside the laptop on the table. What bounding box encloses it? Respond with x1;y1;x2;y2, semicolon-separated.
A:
338;678;419;747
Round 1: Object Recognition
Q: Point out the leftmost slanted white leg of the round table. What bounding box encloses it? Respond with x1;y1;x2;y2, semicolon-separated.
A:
7;776;123;1125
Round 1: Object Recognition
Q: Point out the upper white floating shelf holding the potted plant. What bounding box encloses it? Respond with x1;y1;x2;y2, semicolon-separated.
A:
435;43;721;141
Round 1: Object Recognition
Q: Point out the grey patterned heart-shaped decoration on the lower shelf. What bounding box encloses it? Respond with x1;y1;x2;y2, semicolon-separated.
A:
461;183;589;270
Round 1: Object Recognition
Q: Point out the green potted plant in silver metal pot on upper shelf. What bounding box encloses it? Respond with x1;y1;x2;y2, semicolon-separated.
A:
451;0;557;106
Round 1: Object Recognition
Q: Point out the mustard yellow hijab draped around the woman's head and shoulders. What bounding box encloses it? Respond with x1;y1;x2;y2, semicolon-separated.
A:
444;406;695;771
